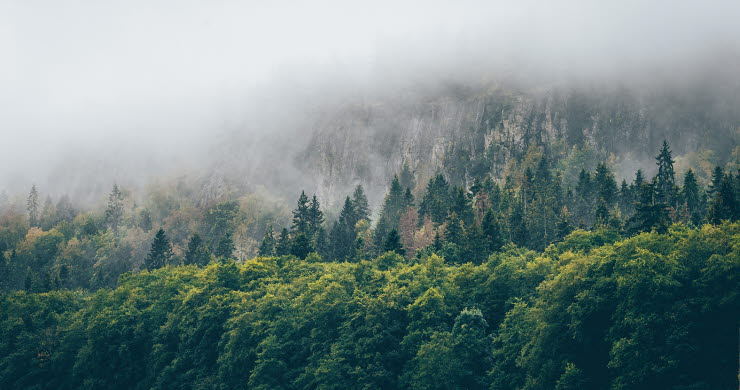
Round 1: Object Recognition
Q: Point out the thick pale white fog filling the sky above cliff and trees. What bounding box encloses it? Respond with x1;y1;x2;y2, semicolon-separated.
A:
0;0;740;201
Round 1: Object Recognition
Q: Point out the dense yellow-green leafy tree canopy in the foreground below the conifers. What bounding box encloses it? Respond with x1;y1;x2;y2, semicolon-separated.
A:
0;223;740;389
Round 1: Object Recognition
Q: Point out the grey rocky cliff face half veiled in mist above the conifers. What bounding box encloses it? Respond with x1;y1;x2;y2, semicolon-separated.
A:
297;82;740;207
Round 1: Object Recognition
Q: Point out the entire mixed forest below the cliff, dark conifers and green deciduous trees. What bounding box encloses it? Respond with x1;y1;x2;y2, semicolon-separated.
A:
0;141;740;389
